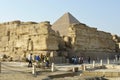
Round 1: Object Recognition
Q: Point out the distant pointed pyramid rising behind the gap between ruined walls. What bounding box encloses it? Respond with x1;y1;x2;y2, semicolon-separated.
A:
52;12;80;36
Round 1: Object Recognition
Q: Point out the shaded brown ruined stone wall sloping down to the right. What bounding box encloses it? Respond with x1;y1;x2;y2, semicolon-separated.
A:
68;24;115;56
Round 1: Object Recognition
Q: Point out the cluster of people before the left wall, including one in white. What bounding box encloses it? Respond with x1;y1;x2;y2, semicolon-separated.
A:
27;53;49;67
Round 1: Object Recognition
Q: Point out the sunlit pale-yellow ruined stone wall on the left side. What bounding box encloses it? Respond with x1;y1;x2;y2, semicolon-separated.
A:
0;21;60;60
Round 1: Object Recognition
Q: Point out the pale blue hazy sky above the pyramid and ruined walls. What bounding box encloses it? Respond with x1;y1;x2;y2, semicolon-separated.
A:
0;0;120;36
